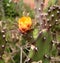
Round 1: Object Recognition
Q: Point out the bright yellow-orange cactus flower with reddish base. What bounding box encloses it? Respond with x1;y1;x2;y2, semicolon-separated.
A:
18;16;32;33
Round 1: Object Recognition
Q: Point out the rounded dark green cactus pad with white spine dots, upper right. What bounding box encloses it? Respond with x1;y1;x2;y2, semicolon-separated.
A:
47;5;60;31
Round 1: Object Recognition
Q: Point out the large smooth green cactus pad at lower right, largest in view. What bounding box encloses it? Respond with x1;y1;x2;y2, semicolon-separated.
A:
29;30;52;63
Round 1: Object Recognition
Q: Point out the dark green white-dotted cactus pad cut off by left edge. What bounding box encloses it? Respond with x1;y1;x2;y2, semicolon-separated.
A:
0;30;6;59
